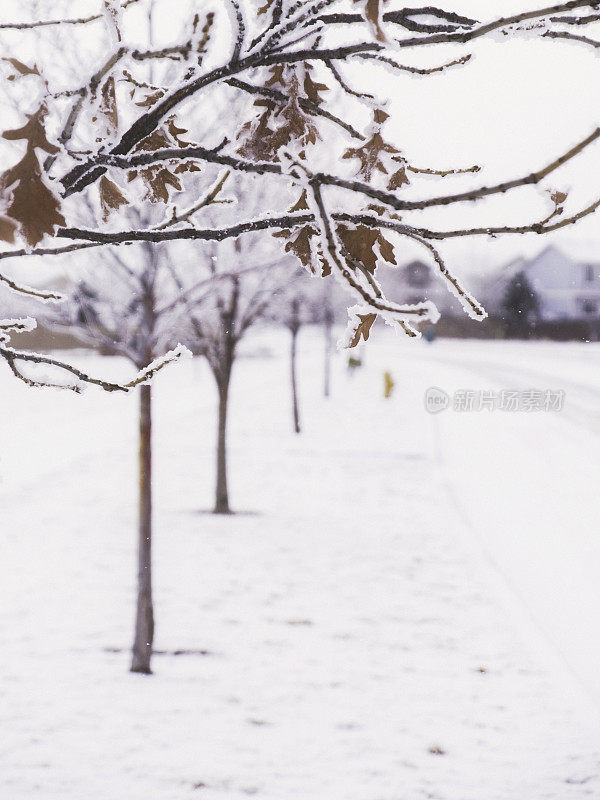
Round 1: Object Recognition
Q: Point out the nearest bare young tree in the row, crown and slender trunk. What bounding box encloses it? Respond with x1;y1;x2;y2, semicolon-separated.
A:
59;203;235;674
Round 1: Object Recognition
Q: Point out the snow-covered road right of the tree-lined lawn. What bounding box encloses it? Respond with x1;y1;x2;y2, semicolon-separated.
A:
386;343;600;721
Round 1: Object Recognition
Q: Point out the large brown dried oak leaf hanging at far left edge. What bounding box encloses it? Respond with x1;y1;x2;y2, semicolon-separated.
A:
0;145;66;247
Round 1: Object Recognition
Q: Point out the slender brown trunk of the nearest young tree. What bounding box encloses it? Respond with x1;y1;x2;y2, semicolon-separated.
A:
131;386;154;675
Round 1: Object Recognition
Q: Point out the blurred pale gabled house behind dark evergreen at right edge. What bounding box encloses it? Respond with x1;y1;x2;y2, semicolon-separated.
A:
478;246;600;323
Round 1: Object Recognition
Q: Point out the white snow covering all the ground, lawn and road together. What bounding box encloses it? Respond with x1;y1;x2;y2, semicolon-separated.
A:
0;331;600;800
